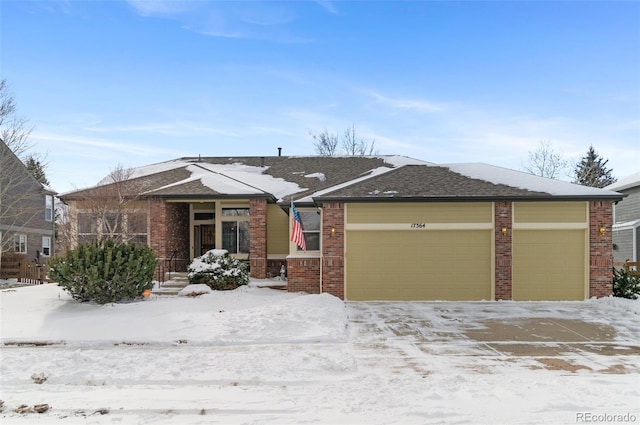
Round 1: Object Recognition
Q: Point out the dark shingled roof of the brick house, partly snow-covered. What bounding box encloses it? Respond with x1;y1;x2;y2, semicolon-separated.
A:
61;156;623;204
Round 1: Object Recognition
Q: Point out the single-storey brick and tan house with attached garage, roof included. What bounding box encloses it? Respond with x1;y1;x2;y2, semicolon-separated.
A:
61;156;623;300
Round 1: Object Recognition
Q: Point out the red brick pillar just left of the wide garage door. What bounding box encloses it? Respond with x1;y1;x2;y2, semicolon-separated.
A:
322;203;344;299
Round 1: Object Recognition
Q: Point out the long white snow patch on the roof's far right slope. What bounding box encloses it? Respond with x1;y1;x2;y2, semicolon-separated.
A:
443;163;618;196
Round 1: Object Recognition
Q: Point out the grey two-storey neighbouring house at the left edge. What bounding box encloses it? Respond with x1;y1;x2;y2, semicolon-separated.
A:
0;140;55;263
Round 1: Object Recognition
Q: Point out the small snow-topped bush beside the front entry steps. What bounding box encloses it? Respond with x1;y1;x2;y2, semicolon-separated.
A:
189;249;249;290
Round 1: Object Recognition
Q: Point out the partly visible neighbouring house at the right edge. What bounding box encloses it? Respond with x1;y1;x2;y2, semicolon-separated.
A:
605;172;640;263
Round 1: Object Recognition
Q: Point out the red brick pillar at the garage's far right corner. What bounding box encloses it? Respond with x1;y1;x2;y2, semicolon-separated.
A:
589;201;613;298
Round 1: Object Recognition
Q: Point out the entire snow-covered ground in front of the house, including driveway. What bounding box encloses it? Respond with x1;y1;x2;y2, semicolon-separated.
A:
0;282;640;425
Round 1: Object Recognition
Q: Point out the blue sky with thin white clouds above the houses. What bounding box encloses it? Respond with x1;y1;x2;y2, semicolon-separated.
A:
0;0;640;192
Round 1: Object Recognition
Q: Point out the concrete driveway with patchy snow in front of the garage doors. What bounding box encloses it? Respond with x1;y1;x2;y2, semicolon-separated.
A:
347;301;640;374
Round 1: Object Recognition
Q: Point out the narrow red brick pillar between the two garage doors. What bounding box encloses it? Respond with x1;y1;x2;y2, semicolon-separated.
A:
494;202;513;300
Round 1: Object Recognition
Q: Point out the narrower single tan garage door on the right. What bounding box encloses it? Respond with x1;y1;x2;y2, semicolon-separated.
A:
512;229;586;301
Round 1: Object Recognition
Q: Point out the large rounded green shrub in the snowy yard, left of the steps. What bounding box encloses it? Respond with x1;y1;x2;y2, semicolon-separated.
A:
49;239;156;304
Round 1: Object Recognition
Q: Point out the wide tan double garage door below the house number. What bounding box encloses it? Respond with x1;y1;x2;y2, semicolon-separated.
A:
346;229;492;300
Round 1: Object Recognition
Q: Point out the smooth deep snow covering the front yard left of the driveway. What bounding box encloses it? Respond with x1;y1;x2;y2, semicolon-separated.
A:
0;285;347;345
